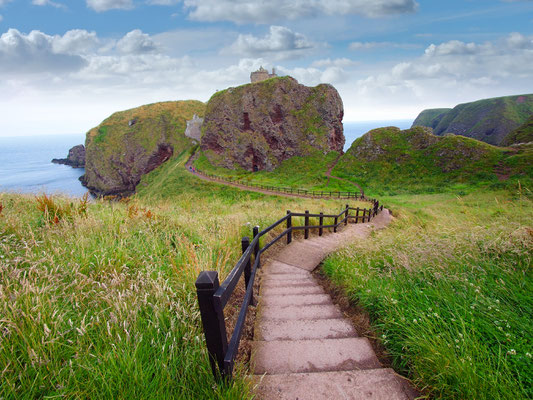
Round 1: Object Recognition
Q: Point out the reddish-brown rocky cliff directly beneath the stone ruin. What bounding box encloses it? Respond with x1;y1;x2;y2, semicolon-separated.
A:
201;77;345;171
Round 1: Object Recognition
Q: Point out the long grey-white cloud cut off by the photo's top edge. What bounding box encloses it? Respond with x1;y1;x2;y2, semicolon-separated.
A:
184;0;418;23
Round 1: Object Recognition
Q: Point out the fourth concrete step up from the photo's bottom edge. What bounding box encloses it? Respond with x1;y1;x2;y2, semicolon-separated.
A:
259;304;342;324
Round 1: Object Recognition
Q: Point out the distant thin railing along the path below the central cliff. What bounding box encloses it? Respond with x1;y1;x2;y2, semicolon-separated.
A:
190;167;366;202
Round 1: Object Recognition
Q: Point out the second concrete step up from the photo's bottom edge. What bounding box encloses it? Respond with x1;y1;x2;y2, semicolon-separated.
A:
252;338;381;374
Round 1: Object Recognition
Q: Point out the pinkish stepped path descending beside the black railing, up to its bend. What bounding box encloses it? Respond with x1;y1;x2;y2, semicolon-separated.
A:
251;210;417;400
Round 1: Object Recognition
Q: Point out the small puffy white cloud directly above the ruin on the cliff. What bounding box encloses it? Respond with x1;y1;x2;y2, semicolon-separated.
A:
229;25;316;60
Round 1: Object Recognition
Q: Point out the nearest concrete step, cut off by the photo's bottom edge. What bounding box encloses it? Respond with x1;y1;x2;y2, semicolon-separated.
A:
253;368;419;400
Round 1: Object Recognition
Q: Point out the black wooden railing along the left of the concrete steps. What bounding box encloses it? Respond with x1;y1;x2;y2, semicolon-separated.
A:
196;200;383;379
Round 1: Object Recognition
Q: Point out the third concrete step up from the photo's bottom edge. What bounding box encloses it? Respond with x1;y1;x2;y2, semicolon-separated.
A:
255;318;357;342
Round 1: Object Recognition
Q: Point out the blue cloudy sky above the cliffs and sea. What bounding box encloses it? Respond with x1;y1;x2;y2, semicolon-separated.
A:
0;0;533;136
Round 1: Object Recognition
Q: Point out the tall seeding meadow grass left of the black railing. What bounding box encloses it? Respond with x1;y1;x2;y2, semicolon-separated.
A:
0;160;354;399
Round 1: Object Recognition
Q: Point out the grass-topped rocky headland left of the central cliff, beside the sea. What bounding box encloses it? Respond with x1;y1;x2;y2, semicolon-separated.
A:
80;101;205;195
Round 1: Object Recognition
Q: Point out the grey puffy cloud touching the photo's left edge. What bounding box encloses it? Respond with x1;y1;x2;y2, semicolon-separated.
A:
0;29;86;74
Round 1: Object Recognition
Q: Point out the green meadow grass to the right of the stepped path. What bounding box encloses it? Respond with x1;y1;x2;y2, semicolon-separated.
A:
323;188;533;399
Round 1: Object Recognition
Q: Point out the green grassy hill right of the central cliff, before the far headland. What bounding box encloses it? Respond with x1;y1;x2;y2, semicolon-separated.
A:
333;127;533;194
